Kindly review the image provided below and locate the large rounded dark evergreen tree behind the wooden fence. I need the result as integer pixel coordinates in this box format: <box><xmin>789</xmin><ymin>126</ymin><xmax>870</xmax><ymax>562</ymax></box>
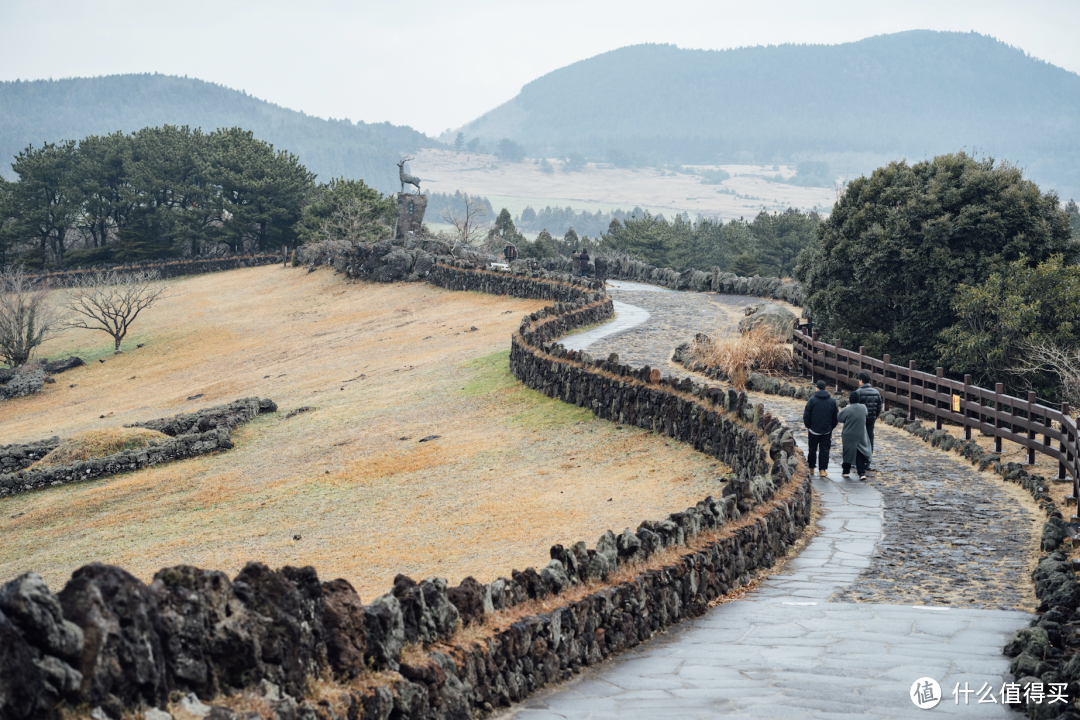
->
<box><xmin>795</xmin><ymin>152</ymin><xmax>1071</xmax><ymax>367</ymax></box>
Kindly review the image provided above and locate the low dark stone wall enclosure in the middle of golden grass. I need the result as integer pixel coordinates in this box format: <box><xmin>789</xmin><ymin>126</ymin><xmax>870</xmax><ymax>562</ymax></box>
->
<box><xmin>0</xmin><ymin>397</ymin><xmax>278</xmax><ymax>497</ymax></box>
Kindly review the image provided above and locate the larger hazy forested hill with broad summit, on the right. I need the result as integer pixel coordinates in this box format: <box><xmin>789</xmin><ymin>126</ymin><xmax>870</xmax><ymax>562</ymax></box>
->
<box><xmin>461</xmin><ymin>30</ymin><xmax>1080</xmax><ymax>196</ymax></box>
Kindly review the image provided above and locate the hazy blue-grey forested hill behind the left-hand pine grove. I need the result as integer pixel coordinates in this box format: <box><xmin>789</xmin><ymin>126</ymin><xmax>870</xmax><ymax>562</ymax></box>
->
<box><xmin>0</xmin><ymin>74</ymin><xmax>438</xmax><ymax>192</ymax></box>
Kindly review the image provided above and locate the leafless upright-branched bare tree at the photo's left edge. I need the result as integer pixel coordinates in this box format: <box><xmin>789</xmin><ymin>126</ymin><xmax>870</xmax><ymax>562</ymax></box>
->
<box><xmin>0</xmin><ymin>269</ymin><xmax>58</xmax><ymax>367</ymax></box>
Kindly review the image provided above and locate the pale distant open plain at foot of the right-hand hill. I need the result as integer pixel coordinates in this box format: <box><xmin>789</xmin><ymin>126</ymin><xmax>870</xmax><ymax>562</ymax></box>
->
<box><xmin>410</xmin><ymin>150</ymin><xmax>836</xmax><ymax>221</ymax></box>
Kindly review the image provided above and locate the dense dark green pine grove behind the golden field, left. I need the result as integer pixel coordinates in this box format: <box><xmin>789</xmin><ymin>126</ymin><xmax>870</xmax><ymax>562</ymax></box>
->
<box><xmin>0</xmin><ymin>125</ymin><xmax>403</xmax><ymax>270</ymax></box>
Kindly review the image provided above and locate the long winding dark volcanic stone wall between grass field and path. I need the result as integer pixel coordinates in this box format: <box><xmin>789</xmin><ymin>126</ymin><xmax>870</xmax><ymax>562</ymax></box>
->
<box><xmin>0</xmin><ymin>267</ymin><xmax>811</xmax><ymax>720</ymax></box>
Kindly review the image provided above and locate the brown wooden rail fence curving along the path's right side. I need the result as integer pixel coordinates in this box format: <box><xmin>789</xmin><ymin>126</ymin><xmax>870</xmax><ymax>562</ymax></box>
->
<box><xmin>792</xmin><ymin>324</ymin><xmax>1080</xmax><ymax>502</ymax></box>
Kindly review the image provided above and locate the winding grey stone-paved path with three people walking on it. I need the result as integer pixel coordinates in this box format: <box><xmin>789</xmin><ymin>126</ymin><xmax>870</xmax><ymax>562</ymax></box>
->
<box><xmin>500</xmin><ymin>287</ymin><xmax>1034</xmax><ymax>720</ymax></box>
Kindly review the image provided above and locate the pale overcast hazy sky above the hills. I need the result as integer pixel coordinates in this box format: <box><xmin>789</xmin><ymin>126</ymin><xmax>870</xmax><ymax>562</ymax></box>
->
<box><xmin>0</xmin><ymin>0</ymin><xmax>1080</xmax><ymax>135</ymax></box>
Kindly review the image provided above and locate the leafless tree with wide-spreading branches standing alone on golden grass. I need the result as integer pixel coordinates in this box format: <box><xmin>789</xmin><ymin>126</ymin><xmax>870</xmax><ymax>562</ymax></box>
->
<box><xmin>64</xmin><ymin>271</ymin><xmax>165</xmax><ymax>353</ymax></box>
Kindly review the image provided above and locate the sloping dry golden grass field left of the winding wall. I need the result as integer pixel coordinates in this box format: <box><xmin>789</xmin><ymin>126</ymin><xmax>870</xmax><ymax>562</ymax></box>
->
<box><xmin>0</xmin><ymin>267</ymin><xmax>723</xmax><ymax>600</ymax></box>
